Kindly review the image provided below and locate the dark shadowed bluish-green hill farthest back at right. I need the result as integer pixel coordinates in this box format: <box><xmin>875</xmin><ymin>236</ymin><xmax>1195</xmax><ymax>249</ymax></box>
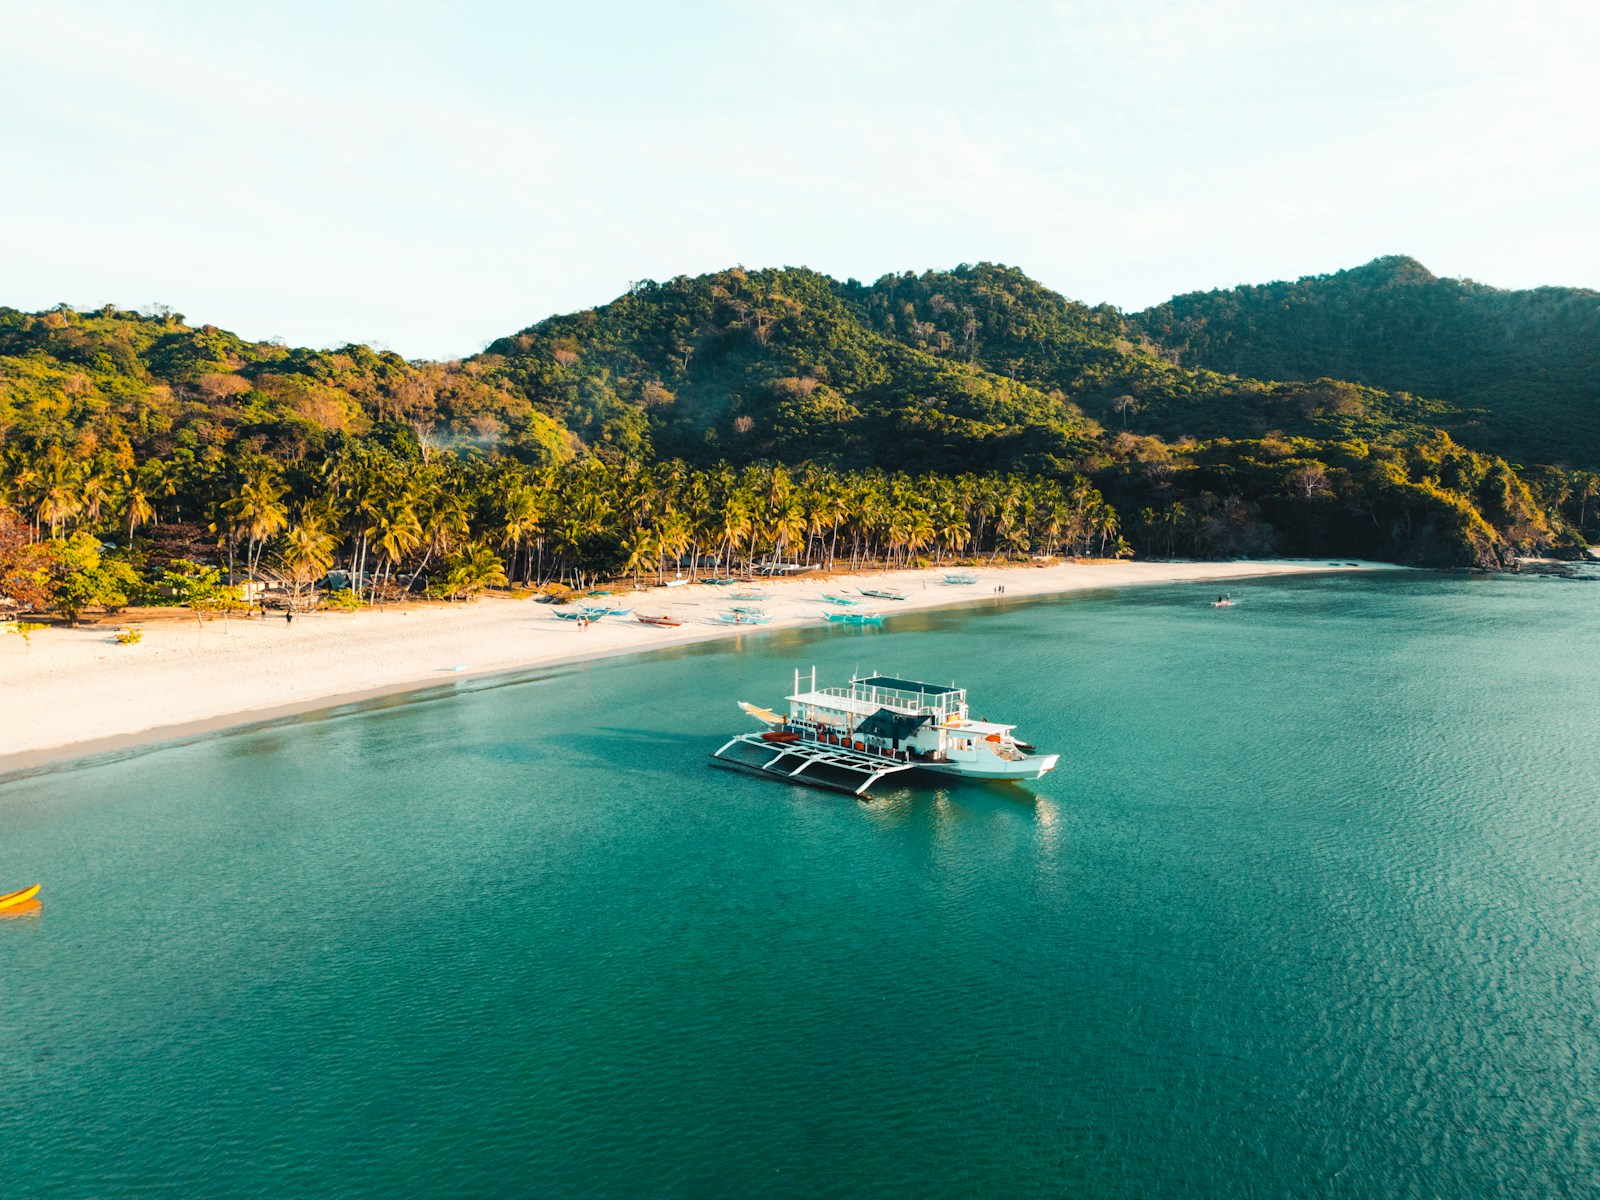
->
<box><xmin>1133</xmin><ymin>256</ymin><xmax>1600</xmax><ymax>469</ymax></box>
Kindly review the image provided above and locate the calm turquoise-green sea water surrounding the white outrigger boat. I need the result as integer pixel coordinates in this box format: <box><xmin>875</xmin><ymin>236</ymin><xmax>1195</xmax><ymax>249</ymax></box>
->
<box><xmin>0</xmin><ymin>576</ymin><xmax>1600</xmax><ymax>1200</ymax></box>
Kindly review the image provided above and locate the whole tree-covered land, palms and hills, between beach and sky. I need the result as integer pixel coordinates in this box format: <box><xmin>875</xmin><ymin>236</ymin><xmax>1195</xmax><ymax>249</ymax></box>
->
<box><xmin>0</xmin><ymin>258</ymin><xmax>1600</xmax><ymax>619</ymax></box>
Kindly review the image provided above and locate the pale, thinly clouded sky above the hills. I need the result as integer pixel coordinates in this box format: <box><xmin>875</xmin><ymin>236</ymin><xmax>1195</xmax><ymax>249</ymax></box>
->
<box><xmin>0</xmin><ymin>0</ymin><xmax>1600</xmax><ymax>358</ymax></box>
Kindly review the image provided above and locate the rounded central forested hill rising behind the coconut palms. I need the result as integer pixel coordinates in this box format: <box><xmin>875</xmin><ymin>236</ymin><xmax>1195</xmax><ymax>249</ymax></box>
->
<box><xmin>472</xmin><ymin>264</ymin><xmax>1465</xmax><ymax>469</ymax></box>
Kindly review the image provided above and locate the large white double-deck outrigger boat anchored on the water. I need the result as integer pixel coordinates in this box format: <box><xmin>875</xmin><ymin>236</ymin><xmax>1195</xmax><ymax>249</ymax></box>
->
<box><xmin>712</xmin><ymin>667</ymin><xmax>1061</xmax><ymax>797</ymax></box>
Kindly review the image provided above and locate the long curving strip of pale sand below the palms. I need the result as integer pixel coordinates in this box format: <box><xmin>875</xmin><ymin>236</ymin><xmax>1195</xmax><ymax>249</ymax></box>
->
<box><xmin>0</xmin><ymin>560</ymin><xmax>1398</xmax><ymax>773</ymax></box>
